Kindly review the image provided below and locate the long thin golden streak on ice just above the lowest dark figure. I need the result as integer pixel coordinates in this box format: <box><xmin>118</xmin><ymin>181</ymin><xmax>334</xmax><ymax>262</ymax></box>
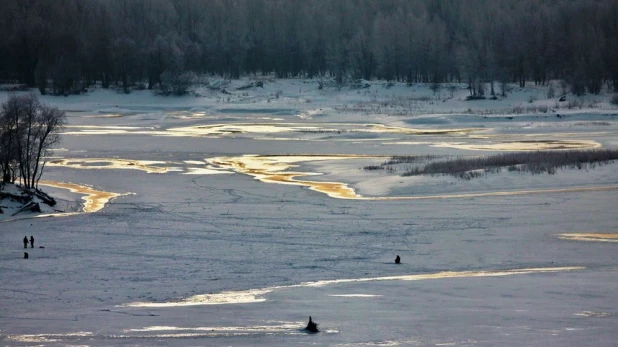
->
<box><xmin>123</xmin><ymin>266</ymin><xmax>585</xmax><ymax>307</ymax></box>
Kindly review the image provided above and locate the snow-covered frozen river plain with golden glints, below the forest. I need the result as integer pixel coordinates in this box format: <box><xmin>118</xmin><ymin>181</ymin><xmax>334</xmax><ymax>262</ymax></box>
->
<box><xmin>0</xmin><ymin>80</ymin><xmax>618</xmax><ymax>347</ymax></box>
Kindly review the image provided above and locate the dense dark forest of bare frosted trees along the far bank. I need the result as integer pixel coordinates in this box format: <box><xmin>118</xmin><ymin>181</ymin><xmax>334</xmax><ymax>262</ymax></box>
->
<box><xmin>0</xmin><ymin>0</ymin><xmax>618</xmax><ymax>94</ymax></box>
